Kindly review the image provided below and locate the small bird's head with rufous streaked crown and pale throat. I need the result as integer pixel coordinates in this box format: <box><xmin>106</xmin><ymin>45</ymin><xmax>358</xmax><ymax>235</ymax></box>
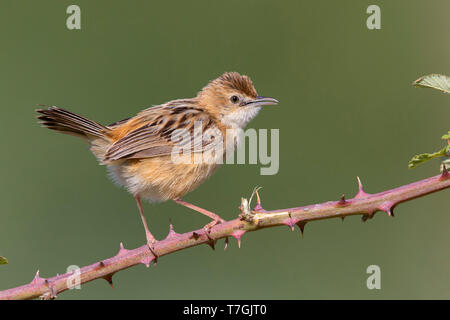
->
<box><xmin>197</xmin><ymin>72</ymin><xmax>278</xmax><ymax>128</ymax></box>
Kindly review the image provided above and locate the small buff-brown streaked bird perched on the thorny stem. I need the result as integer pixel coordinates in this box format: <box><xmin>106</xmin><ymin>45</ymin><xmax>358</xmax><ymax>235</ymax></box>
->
<box><xmin>36</xmin><ymin>72</ymin><xmax>278</xmax><ymax>252</ymax></box>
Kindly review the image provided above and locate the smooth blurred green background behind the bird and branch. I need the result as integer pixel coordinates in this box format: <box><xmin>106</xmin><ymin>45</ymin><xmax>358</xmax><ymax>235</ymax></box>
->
<box><xmin>0</xmin><ymin>0</ymin><xmax>450</xmax><ymax>299</ymax></box>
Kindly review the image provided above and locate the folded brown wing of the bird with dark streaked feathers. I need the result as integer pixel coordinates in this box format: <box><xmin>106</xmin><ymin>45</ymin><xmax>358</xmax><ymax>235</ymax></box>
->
<box><xmin>103</xmin><ymin>105</ymin><xmax>218</xmax><ymax>162</ymax></box>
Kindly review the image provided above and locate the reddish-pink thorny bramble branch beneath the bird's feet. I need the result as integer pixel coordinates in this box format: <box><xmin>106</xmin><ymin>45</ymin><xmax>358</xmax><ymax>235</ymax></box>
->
<box><xmin>0</xmin><ymin>166</ymin><xmax>450</xmax><ymax>299</ymax></box>
